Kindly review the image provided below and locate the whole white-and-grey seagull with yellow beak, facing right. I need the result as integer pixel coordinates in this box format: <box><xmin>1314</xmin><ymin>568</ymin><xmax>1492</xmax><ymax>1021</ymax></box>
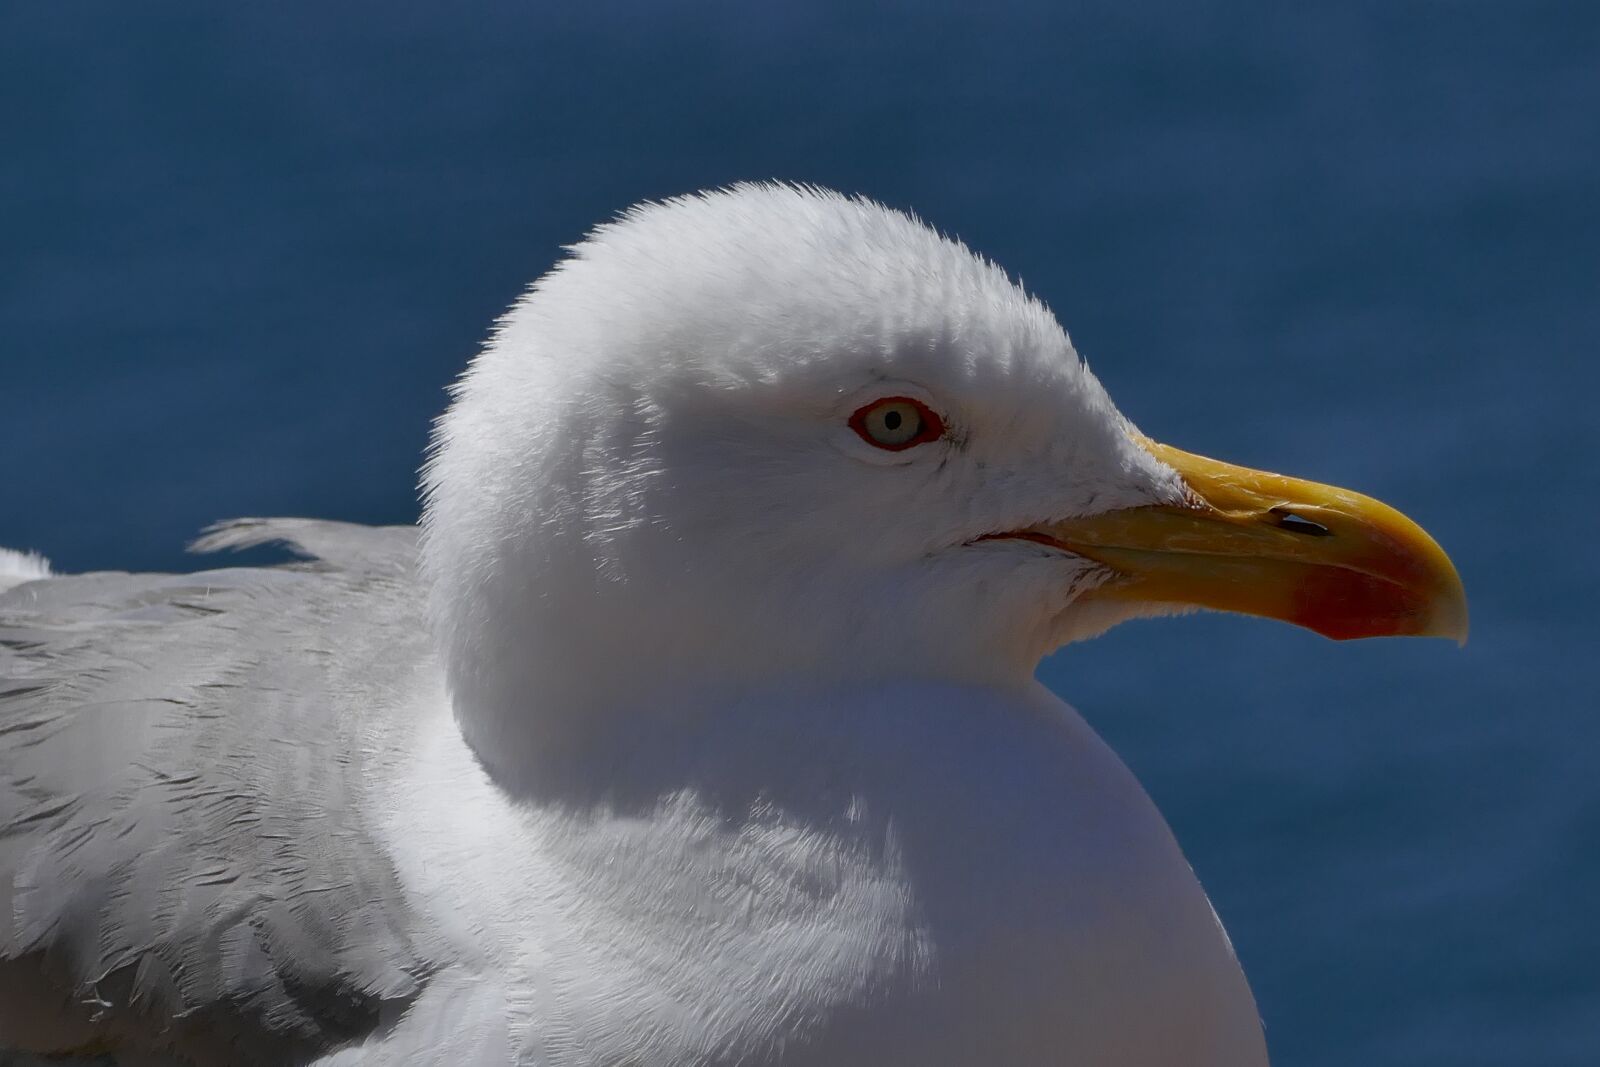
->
<box><xmin>0</xmin><ymin>184</ymin><xmax>1467</xmax><ymax>1067</ymax></box>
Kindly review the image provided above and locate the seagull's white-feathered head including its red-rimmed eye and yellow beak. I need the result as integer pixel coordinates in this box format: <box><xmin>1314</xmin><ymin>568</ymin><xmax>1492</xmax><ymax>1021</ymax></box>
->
<box><xmin>422</xmin><ymin>186</ymin><xmax>1466</xmax><ymax>777</ymax></box>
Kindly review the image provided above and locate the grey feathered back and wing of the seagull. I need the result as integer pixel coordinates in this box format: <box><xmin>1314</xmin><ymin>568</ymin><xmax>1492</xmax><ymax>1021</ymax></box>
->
<box><xmin>0</xmin><ymin>520</ymin><xmax>437</xmax><ymax>1062</ymax></box>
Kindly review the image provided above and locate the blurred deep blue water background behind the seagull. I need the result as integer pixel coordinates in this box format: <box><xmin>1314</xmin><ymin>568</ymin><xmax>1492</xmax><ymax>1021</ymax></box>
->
<box><xmin>0</xmin><ymin>0</ymin><xmax>1600</xmax><ymax>1065</ymax></box>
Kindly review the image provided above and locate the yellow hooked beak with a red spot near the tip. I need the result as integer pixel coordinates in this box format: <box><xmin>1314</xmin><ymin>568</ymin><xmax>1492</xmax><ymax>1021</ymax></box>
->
<box><xmin>1021</xmin><ymin>440</ymin><xmax>1467</xmax><ymax>643</ymax></box>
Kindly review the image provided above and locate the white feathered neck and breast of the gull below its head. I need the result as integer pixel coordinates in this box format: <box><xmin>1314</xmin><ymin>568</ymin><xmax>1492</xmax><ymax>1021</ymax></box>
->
<box><xmin>380</xmin><ymin>685</ymin><xmax>1266</xmax><ymax>1067</ymax></box>
